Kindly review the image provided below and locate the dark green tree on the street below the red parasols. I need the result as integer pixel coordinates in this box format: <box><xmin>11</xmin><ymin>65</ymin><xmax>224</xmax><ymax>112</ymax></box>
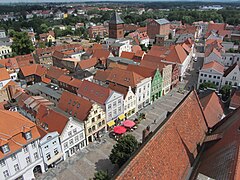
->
<box><xmin>109</xmin><ymin>134</ymin><xmax>138</xmax><ymax>167</ymax></box>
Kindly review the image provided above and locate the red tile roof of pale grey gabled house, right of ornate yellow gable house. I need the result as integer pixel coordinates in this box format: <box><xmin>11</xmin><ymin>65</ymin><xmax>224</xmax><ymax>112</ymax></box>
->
<box><xmin>77</xmin><ymin>80</ymin><xmax>112</xmax><ymax>105</ymax></box>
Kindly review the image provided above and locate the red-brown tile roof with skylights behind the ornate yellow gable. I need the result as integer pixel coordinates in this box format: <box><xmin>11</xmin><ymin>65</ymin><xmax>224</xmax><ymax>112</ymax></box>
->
<box><xmin>58</xmin><ymin>91</ymin><xmax>92</xmax><ymax>121</ymax></box>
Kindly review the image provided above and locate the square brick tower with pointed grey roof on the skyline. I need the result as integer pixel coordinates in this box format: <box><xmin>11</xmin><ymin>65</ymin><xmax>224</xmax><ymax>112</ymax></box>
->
<box><xmin>109</xmin><ymin>12</ymin><xmax>124</xmax><ymax>39</ymax></box>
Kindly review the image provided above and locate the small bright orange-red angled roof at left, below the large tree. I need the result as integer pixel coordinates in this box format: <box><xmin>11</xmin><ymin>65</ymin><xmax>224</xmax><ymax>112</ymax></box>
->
<box><xmin>20</xmin><ymin>64</ymin><xmax>47</xmax><ymax>77</ymax></box>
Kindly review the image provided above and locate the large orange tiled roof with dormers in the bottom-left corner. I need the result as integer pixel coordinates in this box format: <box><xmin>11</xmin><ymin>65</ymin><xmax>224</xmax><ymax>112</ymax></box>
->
<box><xmin>0</xmin><ymin>110</ymin><xmax>40</xmax><ymax>159</ymax></box>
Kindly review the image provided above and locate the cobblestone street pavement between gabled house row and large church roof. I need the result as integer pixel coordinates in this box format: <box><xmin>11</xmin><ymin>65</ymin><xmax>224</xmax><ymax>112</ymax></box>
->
<box><xmin>37</xmin><ymin>58</ymin><xmax>202</xmax><ymax>180</ymax></box>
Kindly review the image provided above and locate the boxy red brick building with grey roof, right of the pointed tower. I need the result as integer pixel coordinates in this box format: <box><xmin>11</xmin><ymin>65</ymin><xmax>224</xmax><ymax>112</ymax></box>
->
<box><xmin>147</xmin><ymin>19</ymin><xmax>170</xmax><ymax>39</ymax></box>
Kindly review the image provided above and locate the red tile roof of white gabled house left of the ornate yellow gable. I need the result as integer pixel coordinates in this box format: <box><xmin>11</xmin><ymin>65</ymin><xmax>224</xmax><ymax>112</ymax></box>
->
<box><xmin>36</xmin><ymin>105</ymin><xmax>69</xmax><ymax>134</ymax></box>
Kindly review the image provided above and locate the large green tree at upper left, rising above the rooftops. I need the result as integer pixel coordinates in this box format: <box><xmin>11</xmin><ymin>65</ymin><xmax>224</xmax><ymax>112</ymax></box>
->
<box><xmin>12</xmin><ymin>32</ymin><xmax>34</xmax><ymax>55</ymax></box>
